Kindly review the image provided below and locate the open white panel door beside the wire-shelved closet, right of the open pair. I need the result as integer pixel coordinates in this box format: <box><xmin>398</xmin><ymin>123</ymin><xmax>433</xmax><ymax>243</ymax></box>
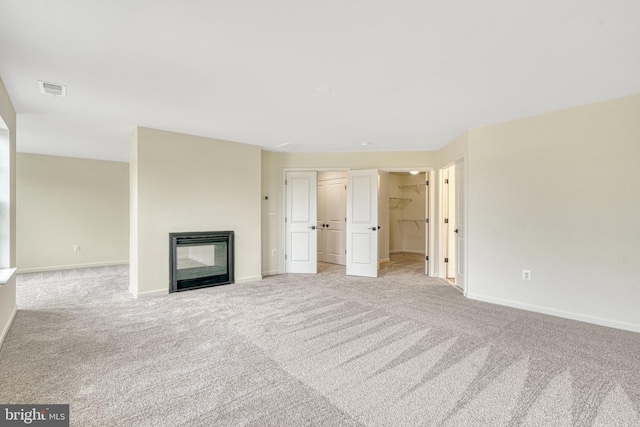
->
<box><xmin>347</xmin><ymin>169</ymin><xmax>378</xmax><ymax>277</ymax></box>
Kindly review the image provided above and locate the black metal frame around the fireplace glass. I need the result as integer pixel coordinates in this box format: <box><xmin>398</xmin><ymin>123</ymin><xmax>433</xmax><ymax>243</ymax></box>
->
<box><xmin>169</xmin><ymin>231</ymin><xmax>235</xmax><ymax>293</ymax></box>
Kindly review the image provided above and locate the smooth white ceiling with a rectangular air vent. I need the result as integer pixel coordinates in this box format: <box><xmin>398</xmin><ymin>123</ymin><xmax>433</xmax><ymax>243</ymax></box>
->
<box><xmin>0</xmin><ymin>0</ymin><xmax>640</xmax><ymax>161</ymax></box>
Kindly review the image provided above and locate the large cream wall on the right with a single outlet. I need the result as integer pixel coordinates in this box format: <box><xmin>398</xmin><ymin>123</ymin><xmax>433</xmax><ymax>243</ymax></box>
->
<box><xmin>467</xmin><ymin>95</ymin><xmax>640</xmax><ymax>332</ymax></box>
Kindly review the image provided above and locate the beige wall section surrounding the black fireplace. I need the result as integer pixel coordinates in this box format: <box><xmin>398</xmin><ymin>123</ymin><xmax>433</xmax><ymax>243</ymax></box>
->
<box><xmin>130</xmin><ymin>127</ymin><xmax>261</xmax><ymax>296</ymax></box>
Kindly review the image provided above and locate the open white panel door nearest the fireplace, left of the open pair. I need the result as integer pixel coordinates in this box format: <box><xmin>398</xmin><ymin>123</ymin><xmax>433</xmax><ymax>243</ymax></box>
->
<box><xmin>285</xmin><ymin>171</ymin><xmax>318</xmax><ymax>274</ymax></box>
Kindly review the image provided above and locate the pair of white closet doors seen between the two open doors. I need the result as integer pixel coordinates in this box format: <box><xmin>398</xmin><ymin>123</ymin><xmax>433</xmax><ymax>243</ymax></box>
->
<box><xmin>317</xmin><ymin>173</ymin><xmax>347</xmax><ymax>265</ymax></box>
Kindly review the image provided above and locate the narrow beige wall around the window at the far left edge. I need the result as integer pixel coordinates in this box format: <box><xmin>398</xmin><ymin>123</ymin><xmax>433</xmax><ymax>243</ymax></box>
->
<box><xmin>0</xmin><ymin>78</ymin><xmax>17</xmax><ymax>346</ymax></box>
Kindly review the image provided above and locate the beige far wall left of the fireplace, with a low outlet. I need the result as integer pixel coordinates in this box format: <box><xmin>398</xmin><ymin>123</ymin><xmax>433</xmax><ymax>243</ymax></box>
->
<box><xmin>17</xmin><ymin>153</ymin><xmax>129</xmax><ymax>273</ymax></box>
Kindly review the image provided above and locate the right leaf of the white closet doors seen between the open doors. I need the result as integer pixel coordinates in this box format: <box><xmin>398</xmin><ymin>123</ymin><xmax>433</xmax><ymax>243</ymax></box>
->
<box><xmin>324</xmin><ymin>178</ymin><xmax>347</xmax><ymax>265</ymax></box>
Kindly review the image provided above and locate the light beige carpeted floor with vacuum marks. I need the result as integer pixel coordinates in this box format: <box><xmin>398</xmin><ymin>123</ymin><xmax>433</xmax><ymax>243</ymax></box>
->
<box><xmin>0</xmin><ymin>255</ymin><xmax>640</xmax><ymax>426</ymax></box>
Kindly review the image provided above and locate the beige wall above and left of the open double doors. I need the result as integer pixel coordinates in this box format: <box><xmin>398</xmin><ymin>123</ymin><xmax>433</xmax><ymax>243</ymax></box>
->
<box><xmin>262</xmin><ymin>151</ymin><xmax>436</xmax><ymax>275</ymax></box>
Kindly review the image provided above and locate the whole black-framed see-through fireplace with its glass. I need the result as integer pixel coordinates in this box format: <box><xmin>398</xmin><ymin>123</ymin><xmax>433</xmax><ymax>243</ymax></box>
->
<box><xmin>169</xmin><ymin>231</ymin><xmax>234</xmax><ymax>292</ymax></box>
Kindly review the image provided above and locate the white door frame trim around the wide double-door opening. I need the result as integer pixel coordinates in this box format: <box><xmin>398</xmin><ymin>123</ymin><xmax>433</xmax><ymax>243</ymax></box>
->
<box><xmin>280</xmin><ymin>166</ymin><xmax>438</xmax><ymax>277</ymax></box>
